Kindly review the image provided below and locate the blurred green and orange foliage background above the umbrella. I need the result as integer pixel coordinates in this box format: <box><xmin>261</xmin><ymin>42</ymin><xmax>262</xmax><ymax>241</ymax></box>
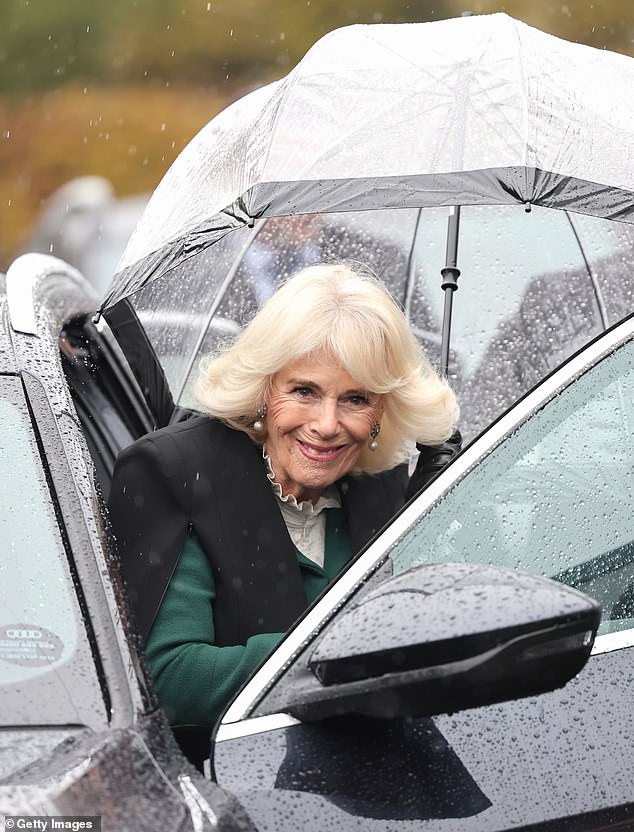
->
<box><xmin>0</xmin><ymin>0</ymin><xmax>634</xmax><ymax>270</ymax></box>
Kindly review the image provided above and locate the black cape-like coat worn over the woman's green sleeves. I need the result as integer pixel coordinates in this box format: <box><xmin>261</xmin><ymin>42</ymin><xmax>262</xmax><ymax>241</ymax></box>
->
<box><xmin>110</xmin><ymin>416</ymin><xmax>414</xmax><ymax>646</ymax></box>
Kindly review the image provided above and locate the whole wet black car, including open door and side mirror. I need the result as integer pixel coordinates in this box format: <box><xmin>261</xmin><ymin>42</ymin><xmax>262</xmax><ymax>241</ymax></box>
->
<box><xmin>0</xmin><ymin>255</ymin><xmax>634</xmax><ymax>830</ymax></box>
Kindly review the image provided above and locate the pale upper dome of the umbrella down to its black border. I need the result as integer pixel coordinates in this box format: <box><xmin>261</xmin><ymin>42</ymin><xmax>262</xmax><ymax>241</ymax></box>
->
<box><xmin>103</xmin><ymin>14</ymin><xmax>634</xmax><ymax>307</ymax></box>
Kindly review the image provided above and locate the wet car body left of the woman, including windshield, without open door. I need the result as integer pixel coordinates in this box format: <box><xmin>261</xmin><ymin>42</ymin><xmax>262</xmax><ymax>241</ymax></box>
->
<box><xmin>0</xmin><ymin>255</ymin><xmax>252</xmax><ymax>832</ymax></box>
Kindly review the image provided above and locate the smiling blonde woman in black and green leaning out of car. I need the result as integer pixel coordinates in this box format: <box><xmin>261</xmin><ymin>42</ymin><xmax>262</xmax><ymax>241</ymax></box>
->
<box><xmin>106</xmin><ymin>265</ymin><xmax>457</xmax><ymax>752</ymax></box>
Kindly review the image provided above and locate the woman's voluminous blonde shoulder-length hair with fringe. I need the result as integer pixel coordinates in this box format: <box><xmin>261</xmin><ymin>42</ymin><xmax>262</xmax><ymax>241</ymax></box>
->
<box><xmin>196</xmin><ymin>263</ymin><xmax>458</xmax><ymax>473</ymax></box>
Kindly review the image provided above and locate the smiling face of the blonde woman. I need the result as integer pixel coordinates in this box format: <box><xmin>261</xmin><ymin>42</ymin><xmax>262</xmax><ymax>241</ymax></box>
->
<box><xmin>265</xmin><ymin>354</ymin><xmax>382</xmax><ymax>502</ymax></box>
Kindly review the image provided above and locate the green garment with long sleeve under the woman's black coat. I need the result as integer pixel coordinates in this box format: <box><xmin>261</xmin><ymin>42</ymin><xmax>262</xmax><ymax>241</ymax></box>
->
<box><xmin>145</xmin><ymin>509</ymin><xmax>352</xmax><ymax>726</ymax></box>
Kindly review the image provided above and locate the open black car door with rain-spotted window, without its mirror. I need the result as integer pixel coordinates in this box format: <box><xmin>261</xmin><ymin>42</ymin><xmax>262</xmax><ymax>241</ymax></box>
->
<box><xmin>213</xmin><ymin>319</ymin><xmax>634</xmax><ymax>832</ymax></box>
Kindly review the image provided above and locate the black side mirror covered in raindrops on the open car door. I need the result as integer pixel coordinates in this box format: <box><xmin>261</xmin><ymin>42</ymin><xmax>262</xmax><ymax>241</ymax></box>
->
<box><xmin>284</xmin><ymin>564</ymin><xmax>601</xmax><ymax>721</ymax></box>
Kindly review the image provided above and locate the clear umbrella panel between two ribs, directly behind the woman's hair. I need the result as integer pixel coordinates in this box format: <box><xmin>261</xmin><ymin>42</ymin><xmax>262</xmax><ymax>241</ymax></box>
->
<box><xmin>179</xmin><ymin>210</ymin><xmax>418</xmax><ymax>407</ymax></box>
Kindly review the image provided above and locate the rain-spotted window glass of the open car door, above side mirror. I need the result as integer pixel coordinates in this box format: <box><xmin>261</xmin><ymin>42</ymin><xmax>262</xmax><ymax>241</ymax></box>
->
<box><xmin>390</xmin><ymin>332</ymin><xmax>634</xmax><ymax>634</ymax></box>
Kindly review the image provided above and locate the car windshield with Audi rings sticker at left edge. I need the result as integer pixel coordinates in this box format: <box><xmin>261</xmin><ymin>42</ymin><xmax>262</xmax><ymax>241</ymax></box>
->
<box><xmin>0</xmin><ymin>376</ymin><xmax>106</xmax><ymax>725</ymax></box>
